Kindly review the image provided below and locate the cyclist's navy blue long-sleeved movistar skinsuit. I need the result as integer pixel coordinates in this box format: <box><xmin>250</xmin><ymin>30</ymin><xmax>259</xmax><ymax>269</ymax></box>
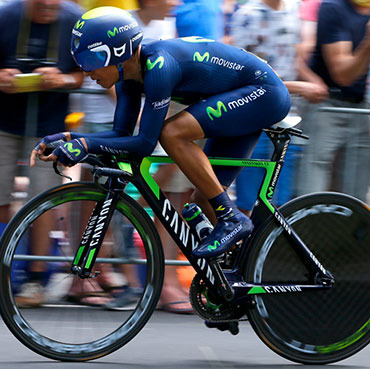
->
<box><xmin>72</xmin><ymin>37</ymin><xmax>290</xmax><ymax>185</ymax></box>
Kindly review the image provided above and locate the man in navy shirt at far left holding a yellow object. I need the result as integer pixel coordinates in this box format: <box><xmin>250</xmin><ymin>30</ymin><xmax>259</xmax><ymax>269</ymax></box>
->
<box><xmin>0</xmin><ymin>0</ymin><xmax>83</xmax><ymax>306</ymax></box>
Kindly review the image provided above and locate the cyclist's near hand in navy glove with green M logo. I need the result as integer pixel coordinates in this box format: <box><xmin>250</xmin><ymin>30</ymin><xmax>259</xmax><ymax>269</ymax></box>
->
<box><xmin>50</xmin><ymin>138</ymin><xmax>88</xmax><ymax>167</ymax></box>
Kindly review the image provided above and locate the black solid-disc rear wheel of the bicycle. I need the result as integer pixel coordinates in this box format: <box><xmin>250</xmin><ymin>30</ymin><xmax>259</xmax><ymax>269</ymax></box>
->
<box><xmin>244</xmin><ymin>193</ymin><xmax>370</xmax><ymax>364</ymax></box>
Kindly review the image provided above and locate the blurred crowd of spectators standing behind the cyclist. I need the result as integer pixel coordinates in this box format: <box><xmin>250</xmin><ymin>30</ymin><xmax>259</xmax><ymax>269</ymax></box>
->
<box><xmin>0</xmin><ymin>0</ymin><xmax>370</xmax><ymax>313</ymax></box>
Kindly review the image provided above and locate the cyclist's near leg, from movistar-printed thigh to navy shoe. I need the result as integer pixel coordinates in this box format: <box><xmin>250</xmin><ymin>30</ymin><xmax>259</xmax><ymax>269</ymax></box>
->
<box><xmin>160</xmin><ymin>82</ymin><xmax>290</xmax><ymax>257</ymax></box>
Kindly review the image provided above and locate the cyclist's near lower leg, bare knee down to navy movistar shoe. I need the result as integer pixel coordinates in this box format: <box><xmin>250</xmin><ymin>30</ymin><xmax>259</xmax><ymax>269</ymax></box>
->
<box><xmin>160</xmin><ymin>111</ymin><xmax>252</xmax><ymax>257</ymax></box>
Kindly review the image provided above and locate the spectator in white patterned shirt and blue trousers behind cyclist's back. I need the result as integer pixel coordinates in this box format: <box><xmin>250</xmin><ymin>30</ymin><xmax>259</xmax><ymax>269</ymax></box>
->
<box><xmin>231</xmin><ymin>0</ymin><xmax>325</xmax><ymax>214</ymax></box>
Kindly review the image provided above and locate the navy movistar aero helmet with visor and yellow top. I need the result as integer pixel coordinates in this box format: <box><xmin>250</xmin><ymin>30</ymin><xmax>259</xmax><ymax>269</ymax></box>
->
<box><xmin>71</xmin><ymin>6</ymin><xmax>143</xmax><ymax>72</ymax></box>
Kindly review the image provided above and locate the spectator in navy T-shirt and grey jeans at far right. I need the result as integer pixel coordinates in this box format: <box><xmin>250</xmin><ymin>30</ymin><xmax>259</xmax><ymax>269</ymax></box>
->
<box><xmin>298</xmin><ymin>0</ymin><xmax>370</xmax><ymax>201</ymax></box>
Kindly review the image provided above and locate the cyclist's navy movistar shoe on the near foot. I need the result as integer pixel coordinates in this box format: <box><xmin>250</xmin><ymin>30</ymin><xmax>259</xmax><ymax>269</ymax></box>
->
<box><xmin>193</xmin><ymin>213</ymin><xmax>253</xmax><ymax>258</ymax></box>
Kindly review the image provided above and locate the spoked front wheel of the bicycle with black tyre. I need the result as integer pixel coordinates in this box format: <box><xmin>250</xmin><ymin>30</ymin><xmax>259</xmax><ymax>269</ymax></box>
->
<box><xmin>0</xmin><ymin>182</ymin><xmax>164</xmax><ymax>361</ymax></box>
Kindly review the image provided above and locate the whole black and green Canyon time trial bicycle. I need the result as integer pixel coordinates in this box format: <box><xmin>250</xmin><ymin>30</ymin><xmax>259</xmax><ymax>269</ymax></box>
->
<box><xmin>0</xmin><ymin>118</ymin><xmax>370</xmax><ymax>364</ymax></box>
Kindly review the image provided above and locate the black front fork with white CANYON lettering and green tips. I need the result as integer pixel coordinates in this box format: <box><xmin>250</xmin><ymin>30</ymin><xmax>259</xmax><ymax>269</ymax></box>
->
<box><xmin>71</xmin><ymin>180</ymin><xmax>121</xmax><ymax>278</ymax></box>
